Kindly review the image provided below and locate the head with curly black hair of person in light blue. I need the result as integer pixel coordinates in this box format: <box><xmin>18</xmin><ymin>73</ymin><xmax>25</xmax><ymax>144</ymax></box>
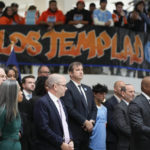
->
<box><xmin>92</xmin><ymin>83</ymin><xmax>108</xmax><ymax>103</ymax></box>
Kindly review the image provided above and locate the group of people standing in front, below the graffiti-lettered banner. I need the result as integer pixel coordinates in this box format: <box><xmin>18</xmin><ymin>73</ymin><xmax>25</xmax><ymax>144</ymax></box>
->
<box><xmin>0</xmin><ymin>62</ymin><xmax>150</xmax><ymax>150</ymax></box>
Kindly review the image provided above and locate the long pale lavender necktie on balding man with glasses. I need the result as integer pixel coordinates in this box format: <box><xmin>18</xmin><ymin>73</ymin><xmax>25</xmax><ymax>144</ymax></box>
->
<box><xmin>57</xmin><ymin>100</ymin><xmax>70</xmax><ymax>143</ymax></box>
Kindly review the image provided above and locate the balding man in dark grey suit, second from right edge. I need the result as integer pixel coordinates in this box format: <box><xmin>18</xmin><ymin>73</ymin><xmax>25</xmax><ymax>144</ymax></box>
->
<box><xmin>114</xmin><ymin>84</ymin><xmax>135</xmax><ymax>150</ymax></box>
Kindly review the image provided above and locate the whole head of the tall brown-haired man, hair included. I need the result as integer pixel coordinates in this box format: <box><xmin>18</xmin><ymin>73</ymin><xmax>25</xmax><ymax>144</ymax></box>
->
<box><xmin>68</xmin><ymin>62</ymin><xmax>84</xmax><ymax>83</ymax></box>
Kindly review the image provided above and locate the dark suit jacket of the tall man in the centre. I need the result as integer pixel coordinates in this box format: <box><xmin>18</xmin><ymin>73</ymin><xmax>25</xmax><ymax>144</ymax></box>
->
<box><xmin>63</xmin><ymin>81</ymin><xmax>97</xmax><ymax>140</ymax></box>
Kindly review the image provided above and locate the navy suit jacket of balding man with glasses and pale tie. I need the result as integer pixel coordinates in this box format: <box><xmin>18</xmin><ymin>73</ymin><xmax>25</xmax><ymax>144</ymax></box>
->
<box><xmin>34</xmin><ymin>94</ymin><xmax>72</xmax><ymax>150</ymax></box>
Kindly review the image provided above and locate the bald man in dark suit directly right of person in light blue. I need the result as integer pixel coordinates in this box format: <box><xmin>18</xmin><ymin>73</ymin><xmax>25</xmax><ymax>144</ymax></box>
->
<box><xmin>104</xmin><ymin>81</ymin><xmax>125</xmax><ymax>150</ymax></box>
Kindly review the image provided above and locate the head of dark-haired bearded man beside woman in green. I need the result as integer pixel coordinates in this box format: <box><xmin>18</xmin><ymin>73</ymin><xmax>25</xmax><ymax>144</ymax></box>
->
<box><xmin>22</xmin><ymin>75</ymin><xmax>35</xmax><ymax>93</ymax></box>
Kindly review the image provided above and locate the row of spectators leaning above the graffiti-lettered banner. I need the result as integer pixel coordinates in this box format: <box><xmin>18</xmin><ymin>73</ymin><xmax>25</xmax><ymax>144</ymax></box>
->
<box><xmin>0</xmin><ymin>0</ymin><xmax>150</xmax><ymax>32</ymax></box>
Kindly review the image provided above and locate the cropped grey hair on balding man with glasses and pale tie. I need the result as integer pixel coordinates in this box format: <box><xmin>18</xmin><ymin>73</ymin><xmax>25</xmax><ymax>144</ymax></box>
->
<box><xmin>46</xmin><ymin>74</ymin><xmax>63</xmax><ymax>89</ymax></box>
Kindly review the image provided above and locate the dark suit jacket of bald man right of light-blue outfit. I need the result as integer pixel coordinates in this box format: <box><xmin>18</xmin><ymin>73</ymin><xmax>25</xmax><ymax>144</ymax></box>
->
<box><xmin>104</xmin><ymin>96</ymin><xmax>118</xmax><ymax>144</ymax></box>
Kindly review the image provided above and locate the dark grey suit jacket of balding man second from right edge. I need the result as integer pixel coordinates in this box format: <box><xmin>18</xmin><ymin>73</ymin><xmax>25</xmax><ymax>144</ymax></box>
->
<box><xmin>114</xmin><ymin>100</ymin><xmax>131</xmax><ymax>150</ymax></box>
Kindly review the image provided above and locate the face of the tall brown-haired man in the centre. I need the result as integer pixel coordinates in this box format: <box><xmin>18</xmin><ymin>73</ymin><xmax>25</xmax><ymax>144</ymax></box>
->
<box><xmin>70</xmin><ymin>65</ymin><xmax>84</xmax><ymax>81</ymax></box>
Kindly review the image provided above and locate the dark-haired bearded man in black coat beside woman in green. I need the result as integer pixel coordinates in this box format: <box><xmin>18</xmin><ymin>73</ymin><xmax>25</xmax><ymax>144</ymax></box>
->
<box><xmin>18</xmin><ymin>75</ymin><xmax>35</xmax><ymax>150</ymax></box>
